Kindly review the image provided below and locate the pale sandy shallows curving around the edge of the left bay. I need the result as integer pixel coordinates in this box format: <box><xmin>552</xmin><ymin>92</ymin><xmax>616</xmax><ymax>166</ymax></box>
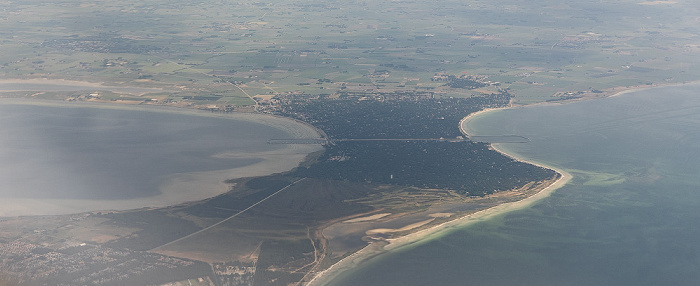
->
<box><xmin>0</xmin><ymin>98</ymin><xmax>321</xmax><ymax>217</ymax></box>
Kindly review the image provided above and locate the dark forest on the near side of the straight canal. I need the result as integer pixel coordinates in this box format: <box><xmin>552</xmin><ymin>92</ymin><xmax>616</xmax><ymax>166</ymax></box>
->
<box><xmin>295</xmin><ymin>141</ymin><xmax>556</xmax><ymax>196</ymax></box>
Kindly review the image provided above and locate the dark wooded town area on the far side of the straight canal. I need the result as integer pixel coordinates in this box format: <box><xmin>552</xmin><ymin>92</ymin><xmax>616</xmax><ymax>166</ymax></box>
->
<box><xmin>281</xmin><ymin>93</ymin><xmax>510</xmax><ymax>139</ymax></box>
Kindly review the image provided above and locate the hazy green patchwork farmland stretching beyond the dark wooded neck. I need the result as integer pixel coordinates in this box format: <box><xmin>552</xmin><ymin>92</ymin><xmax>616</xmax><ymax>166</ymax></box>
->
<box><xmin>0</xmin><ymin>0</ymin><xmax>700</xmax><ymax>105</ymax></box>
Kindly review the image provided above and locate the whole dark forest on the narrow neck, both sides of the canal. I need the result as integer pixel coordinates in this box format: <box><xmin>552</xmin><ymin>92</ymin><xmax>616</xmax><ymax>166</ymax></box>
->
<box><xmin>286</xmin><ymin>94</ymin><xmax>556</xmax><ymax>196</ymax></box>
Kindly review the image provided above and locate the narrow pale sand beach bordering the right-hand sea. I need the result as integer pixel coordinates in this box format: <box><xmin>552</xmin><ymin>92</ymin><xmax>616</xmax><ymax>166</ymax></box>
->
<box><xmin>306</xmin><ymin>105</ymin><xmax>572</xmax><ymax>285</ymax></box>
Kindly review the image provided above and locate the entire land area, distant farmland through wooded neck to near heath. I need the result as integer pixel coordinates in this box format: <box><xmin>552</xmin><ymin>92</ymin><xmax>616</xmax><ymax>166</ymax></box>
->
<box><xmin>0</xmin><ymin>0</ymin><xmax>700</xmax><ymax>285</ymax></box>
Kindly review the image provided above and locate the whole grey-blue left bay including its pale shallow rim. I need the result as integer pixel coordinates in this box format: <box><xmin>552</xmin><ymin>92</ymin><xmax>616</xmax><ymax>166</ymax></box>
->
<box><xmin>0</xmin><ymin>100</ymin><xmax>320</xmax><ymax>216</ymax></box>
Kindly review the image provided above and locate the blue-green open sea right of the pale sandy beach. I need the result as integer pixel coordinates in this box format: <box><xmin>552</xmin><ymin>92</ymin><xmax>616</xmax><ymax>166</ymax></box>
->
<box><xmin>331</xmin><ymin>85</ymin><xmax>700</xmax><ymax>285</ymax></box>
